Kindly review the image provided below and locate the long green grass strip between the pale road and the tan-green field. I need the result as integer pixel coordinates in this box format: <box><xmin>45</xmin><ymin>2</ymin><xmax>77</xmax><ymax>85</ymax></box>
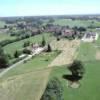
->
<box><xmin>2</xmin><ymin>51</ymin><xmax>59</xmax><ymax>79</ymax></box>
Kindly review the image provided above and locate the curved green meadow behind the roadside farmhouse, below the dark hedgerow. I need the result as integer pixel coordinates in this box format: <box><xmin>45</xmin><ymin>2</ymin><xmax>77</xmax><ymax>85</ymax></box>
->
<box><xmin>4</xmin><ymin>33</ymin><xmax>54</xmax><ymax>56</ymax></box>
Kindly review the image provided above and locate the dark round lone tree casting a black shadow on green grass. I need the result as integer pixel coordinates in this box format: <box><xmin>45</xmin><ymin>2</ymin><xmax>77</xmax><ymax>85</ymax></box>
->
<box><xmin>68</xmin><ymin>60</ymin><xmax>85</xmax><ymax>76</ymax></box>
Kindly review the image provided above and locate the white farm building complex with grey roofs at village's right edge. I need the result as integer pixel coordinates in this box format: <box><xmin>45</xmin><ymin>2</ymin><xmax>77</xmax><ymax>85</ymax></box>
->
<box><xmin>82</xmin><ymin>32</ymin><xmax>98</xmax><ymax>42</ymax></box>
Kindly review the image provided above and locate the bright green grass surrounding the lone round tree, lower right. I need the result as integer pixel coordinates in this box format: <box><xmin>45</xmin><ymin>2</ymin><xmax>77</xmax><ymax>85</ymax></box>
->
<box><xmin>50</xmin><ymin>61</ymin><xmax>100</xmax><ymax>100</ymax></box>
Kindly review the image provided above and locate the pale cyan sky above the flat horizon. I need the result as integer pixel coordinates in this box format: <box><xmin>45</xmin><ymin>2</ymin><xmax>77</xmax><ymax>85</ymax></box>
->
<box><xmin>0</xmin><ymin>0</ymin><xmax>100</xmax><ymax>17</ymax></box>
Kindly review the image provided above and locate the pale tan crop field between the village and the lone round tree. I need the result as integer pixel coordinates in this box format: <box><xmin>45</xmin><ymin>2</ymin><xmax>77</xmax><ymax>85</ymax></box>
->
<box><xmin>51</xmin><ymin>39</ymin><xmax>80</xmax><ymax>66</ymax></box>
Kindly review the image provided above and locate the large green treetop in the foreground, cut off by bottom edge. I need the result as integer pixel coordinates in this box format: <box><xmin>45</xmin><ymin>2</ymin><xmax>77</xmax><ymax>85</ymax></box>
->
<box><xmin>41</xmin><ymin>78</ymin><xmax>63</xmax><ymax>100</ymax></box>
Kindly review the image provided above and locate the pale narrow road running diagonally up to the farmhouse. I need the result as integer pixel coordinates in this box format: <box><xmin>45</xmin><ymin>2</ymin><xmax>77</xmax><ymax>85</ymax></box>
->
<box><xmin>0</xmin><ymin>48</ymin><xmax>44</xmax><ymax>78</ymax></box>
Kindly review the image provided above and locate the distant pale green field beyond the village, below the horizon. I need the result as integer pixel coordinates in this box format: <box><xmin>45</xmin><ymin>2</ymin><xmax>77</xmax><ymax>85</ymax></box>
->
<box><xmin>54</xmin><ymin>19</ymin><xmax>100</xmax><ymax>27</ymax></box>
